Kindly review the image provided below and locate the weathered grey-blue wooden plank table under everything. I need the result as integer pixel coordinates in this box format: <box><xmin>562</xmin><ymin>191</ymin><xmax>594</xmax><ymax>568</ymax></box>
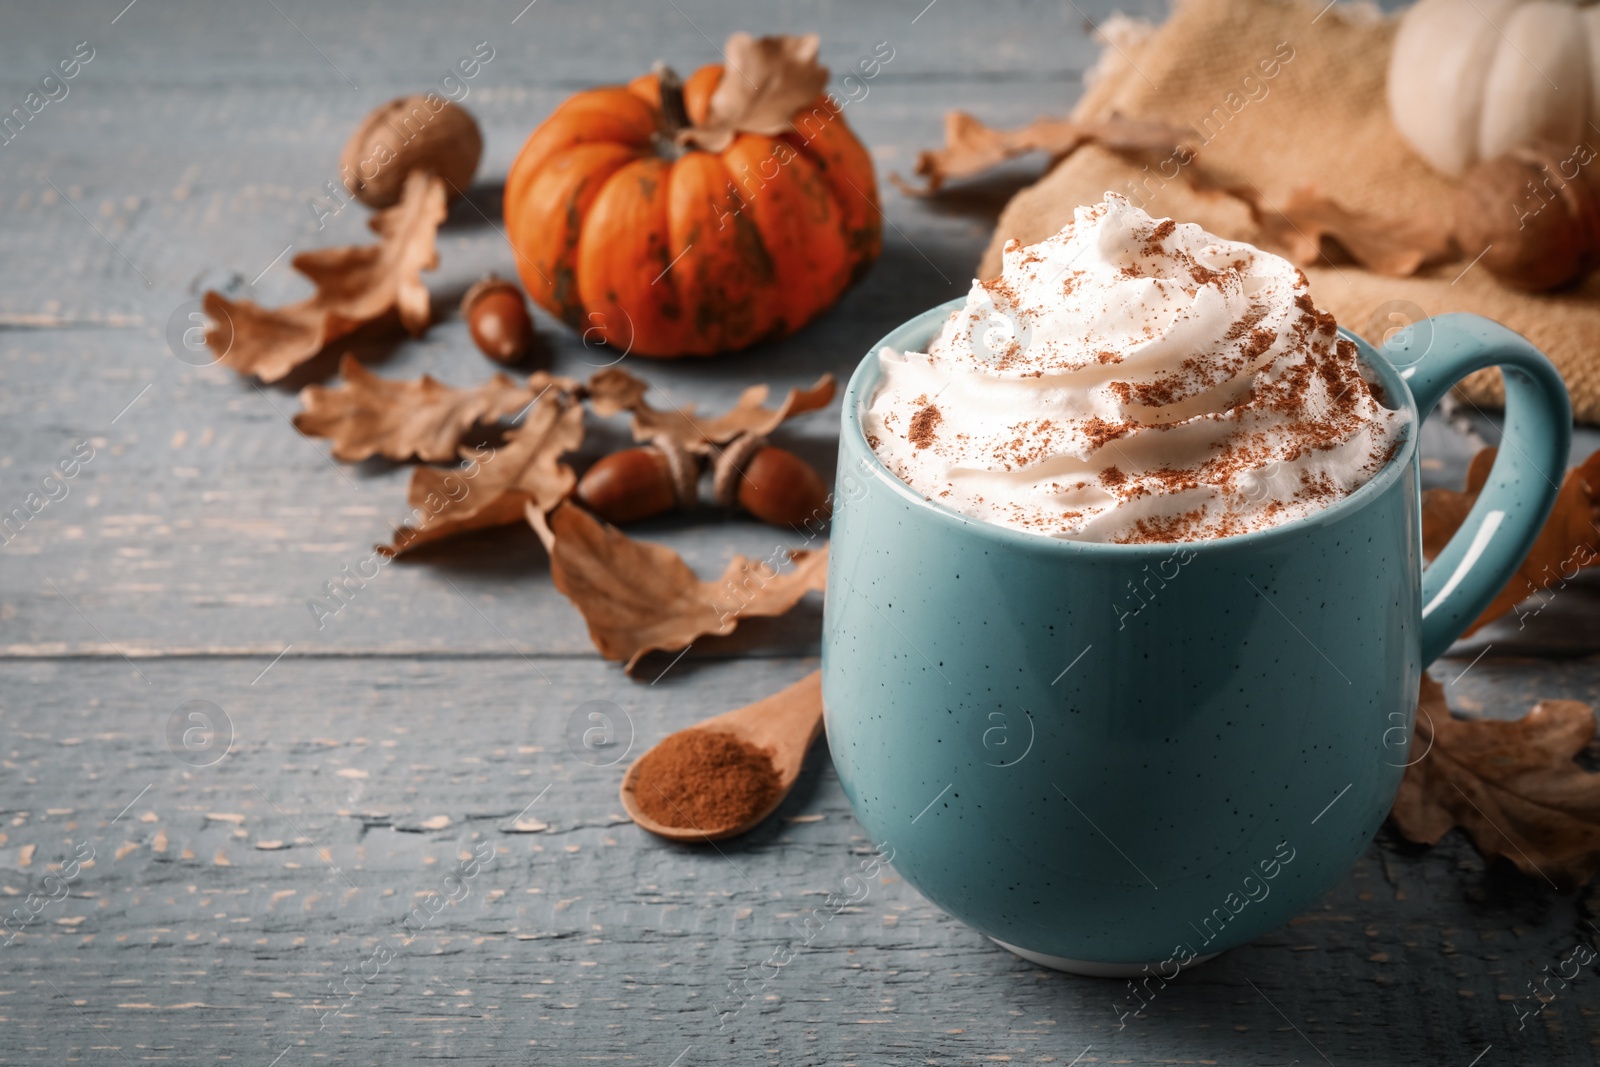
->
<box><xmin>0</xmin><ymin>0</ymin><xmax>1600</xmax><ymax>1067</ymax></box>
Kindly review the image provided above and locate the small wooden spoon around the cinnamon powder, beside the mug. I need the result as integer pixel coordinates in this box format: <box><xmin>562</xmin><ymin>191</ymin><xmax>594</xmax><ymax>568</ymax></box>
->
<box><xmin>622</xmin><ymin>670</ymin><xmax>822</xmax><ymax>841</ymax></box>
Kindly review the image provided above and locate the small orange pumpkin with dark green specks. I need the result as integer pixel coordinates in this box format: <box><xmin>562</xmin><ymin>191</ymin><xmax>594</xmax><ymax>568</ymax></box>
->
<box><xmin>506</xmin><ymin>66</ymin><xmax>882</xmax><ymax>357</ymax></box>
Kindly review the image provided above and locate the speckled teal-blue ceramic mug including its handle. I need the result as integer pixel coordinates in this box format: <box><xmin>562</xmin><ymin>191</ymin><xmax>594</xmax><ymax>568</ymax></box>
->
<box><xmin>822</xmin><ymin>301</ymin><xmax>1571</xmax><ymax>976</ymax></box>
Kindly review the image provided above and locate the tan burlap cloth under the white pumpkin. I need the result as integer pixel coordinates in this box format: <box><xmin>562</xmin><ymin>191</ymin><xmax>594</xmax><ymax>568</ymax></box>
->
<box><xmin>979</xmin><ymin>0</ymin><xmax>1600</xmax><ymax>422</ymax></box>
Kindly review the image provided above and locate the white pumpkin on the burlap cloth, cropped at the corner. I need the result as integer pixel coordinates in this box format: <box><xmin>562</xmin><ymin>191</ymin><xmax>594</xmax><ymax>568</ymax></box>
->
<box><xmin>1389</xmin><ymin>0</ymin><xmax>1600</xmax><ymax>176</ymax></box>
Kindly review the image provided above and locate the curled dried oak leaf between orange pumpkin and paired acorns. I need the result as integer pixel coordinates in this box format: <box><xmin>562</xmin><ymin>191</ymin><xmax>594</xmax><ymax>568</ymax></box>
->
<box><xmin>586</xmin><ymin>366</ymin><xmax>835</xmax><ymax>454</ymax></box>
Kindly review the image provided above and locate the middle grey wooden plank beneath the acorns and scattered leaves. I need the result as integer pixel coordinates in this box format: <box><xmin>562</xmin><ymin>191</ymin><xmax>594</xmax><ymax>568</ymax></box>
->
<box><xmin>0</xmin><ymin>355</ymin><xmax>1600</xmax><ymax>656</ymax></box>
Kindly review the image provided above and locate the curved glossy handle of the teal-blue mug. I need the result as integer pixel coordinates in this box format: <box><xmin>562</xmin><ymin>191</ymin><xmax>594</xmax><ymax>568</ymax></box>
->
<box><xmin>1379</xmin><ymin>314</ymin><xmax>1573</xmax><ymax>667</ymax></box>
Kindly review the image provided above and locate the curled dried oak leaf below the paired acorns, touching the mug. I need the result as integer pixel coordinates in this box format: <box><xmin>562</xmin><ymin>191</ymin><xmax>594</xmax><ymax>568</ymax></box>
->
<box><xmin>540</xmin><ymin>502</ymin><xmax>827</xmax><ymax>672</ymax></box>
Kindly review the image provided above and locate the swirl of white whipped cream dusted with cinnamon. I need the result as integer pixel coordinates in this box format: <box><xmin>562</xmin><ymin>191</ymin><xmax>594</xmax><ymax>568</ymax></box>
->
<box><xmin>862</xmin><ymin>194</ymin><xmax>1408</xmax><ymax>542</ymax></box>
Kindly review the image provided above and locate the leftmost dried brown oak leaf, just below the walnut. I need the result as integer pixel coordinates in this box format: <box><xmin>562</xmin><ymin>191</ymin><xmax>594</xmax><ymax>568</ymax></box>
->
<box><xmin>205</xmin><ymin>171</ymin><xmax>446</xmax><ymax>382</ymax></box>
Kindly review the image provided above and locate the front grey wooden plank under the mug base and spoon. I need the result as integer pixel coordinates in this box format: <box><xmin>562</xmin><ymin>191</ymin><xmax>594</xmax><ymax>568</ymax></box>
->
<box><xmin>0</xmin><ymin>656</ymin><xmax>1600</xmax><ymax>1064</ymax></box>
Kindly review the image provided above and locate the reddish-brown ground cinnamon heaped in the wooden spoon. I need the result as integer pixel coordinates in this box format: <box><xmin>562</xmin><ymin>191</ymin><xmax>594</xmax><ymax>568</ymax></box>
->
<box><xmin>634</xmin><ymin>729</ymin><xmax>779</xmax><ymax>830</ymax></box>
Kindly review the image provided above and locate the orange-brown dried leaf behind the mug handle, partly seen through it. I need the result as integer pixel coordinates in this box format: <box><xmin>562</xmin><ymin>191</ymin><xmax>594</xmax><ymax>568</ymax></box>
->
<box><xmin>1422</xmin><ymin>448</ymin><xmax>1600</xmax><ymax>633</ymax></box>
